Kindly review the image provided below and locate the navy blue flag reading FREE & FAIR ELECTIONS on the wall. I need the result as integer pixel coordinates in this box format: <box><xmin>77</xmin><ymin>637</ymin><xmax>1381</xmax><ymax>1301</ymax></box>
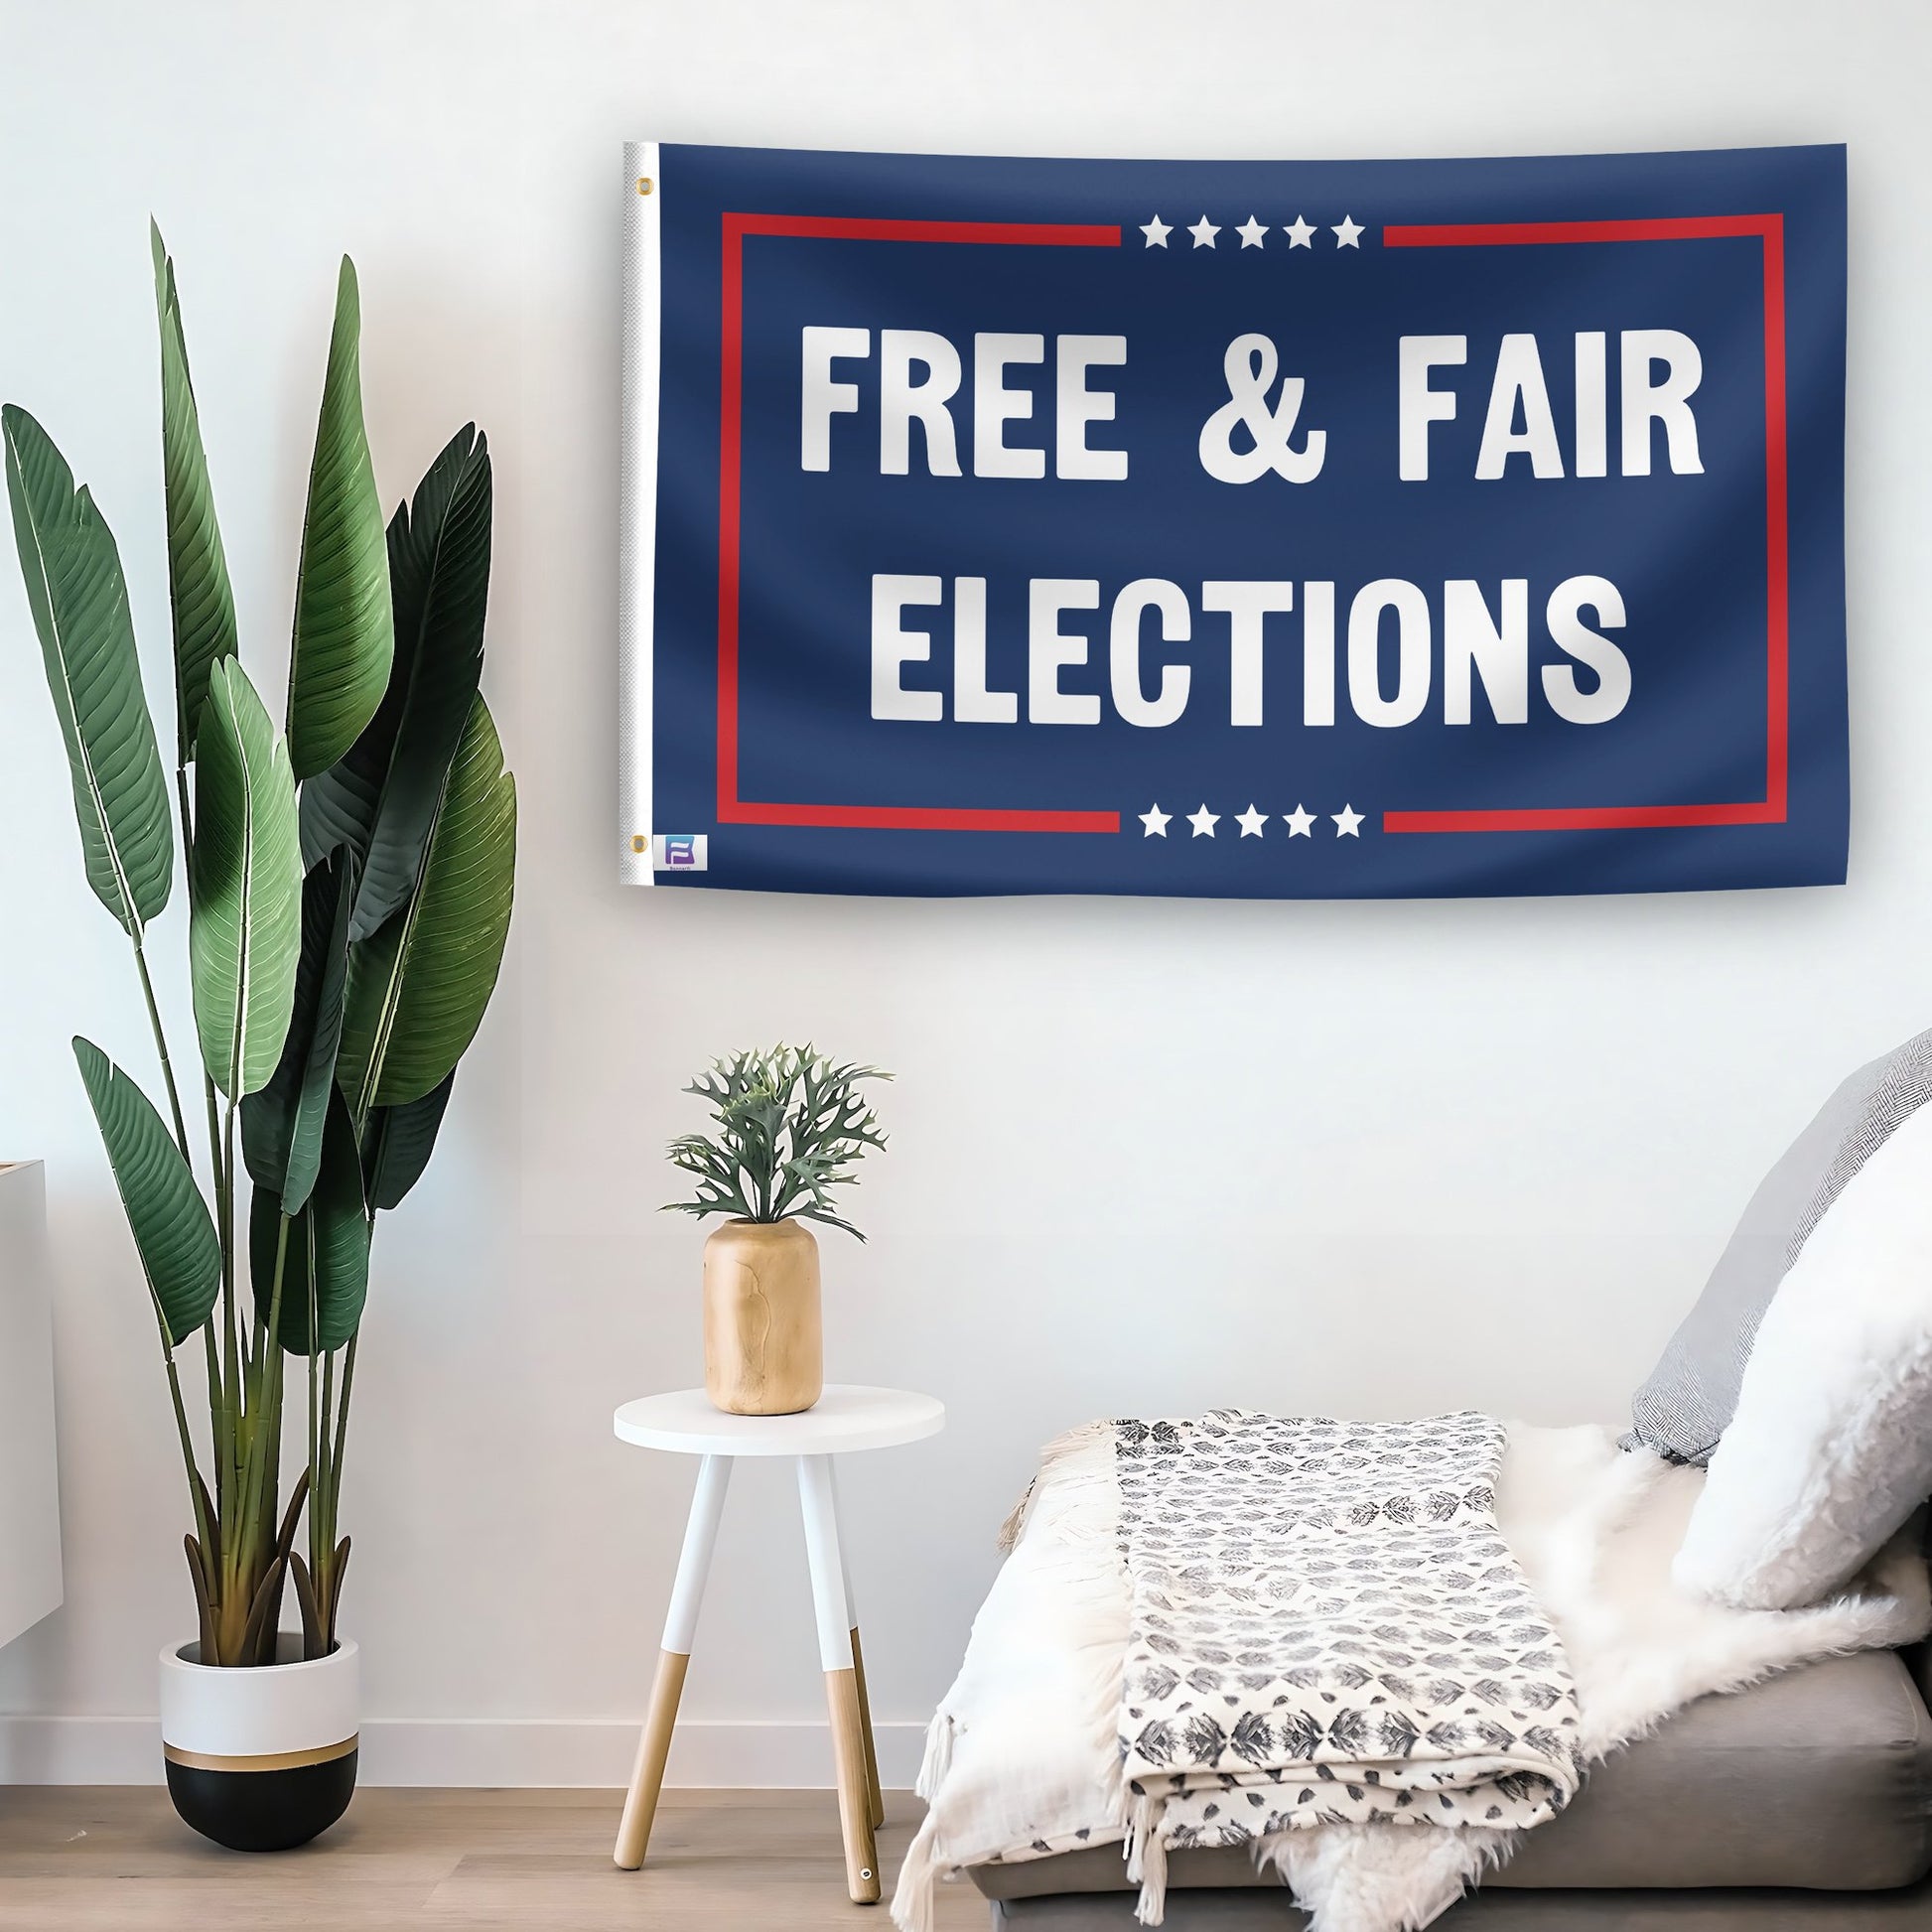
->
<box><xmin>621</xmin><ymin>145</ymin><xmax>1847</xmax><ymax>898</ymax></box>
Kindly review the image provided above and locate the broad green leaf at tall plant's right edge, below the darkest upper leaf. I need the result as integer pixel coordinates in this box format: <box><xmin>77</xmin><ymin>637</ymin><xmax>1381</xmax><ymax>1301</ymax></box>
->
<box><xmin>337</xmin><ymin>698</ymin><xmax>516</xmax><ymax>1121</ymax></box>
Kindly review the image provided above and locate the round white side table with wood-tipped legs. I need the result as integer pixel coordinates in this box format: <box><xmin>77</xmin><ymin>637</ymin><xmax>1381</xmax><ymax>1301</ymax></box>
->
<box><xmin>613</xmin><ymin>1383</ymin><xmax>947</xmax><ymax>1905</ymax></box>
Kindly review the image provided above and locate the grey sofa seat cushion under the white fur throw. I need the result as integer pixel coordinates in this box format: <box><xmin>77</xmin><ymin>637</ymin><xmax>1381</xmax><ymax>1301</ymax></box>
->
<box><xmin>972</xmin><ymin>1650</ymin><xmax>1932</xmax><ymax>1899</ymax></box>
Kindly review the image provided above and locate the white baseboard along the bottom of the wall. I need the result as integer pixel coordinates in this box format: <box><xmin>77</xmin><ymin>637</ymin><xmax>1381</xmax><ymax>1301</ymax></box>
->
<box><xmin>0</xmin><ymin>1716</ymin><xmax>925</xmax><ymax>1791</ymax></box>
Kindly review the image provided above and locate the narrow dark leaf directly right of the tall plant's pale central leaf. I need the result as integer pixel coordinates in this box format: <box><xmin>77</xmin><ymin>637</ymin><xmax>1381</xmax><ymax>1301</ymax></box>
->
<box><xmin>241</xmin><ymin>852</ymin><xmax>355</xmax><ymax>1213</ymax></box>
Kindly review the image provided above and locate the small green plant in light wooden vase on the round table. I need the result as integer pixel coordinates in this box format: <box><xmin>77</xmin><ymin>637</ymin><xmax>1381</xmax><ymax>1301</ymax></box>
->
<box><xmin>664</xmin><ymin>1045</ymin><xmax>893</xmax><ymax>1416</ymax></box>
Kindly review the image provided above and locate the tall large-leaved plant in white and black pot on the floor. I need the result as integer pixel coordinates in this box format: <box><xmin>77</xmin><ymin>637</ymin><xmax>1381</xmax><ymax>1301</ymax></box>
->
<box><xmin>0</xmin><ymin>232</ymin><xmax>516</xmax><ymax>1851</ymax></box>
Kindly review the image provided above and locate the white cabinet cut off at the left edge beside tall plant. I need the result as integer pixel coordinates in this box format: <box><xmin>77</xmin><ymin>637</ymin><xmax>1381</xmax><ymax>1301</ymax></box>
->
<box><xmin>0</xmin><ymin>1162</ymin><xmax>60</xmax><ymax>1644</ymax></box>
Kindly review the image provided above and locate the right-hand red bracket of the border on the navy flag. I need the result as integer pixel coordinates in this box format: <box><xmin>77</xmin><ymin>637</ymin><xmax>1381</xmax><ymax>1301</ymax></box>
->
<box><xmin>1381</xmin><ymin>214</ymin><xmax>1791</xmax><ymax>833</ymax></box>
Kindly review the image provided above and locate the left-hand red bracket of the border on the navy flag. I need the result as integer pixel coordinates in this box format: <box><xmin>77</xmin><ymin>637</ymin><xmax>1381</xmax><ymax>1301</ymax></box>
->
<box><xmin>719</xmin><ymin>214</ymin><xmax>1121</xmax><ymax>833</ymax></box>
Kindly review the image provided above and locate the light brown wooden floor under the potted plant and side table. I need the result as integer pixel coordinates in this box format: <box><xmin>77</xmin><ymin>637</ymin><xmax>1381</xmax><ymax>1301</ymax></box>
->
<box><xmin>0</xmin><ymin>1785</ymin><xmax>987</xmax><ymax>1932</ymax></box>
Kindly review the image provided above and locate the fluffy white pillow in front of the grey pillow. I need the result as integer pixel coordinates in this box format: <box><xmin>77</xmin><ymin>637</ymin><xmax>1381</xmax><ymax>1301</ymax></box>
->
<box><xmin>1671</xmin><ymin>1107</ymin><xmax>1932</xmax><ymax>1609</ymax></box>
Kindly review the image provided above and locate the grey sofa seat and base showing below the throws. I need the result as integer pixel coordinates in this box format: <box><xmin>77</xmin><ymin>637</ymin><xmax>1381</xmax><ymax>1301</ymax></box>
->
<box><xmin>968</xmin><ymin>1648</ymin><xmax>1932</xmax><ymax>1932</ymax></box>
